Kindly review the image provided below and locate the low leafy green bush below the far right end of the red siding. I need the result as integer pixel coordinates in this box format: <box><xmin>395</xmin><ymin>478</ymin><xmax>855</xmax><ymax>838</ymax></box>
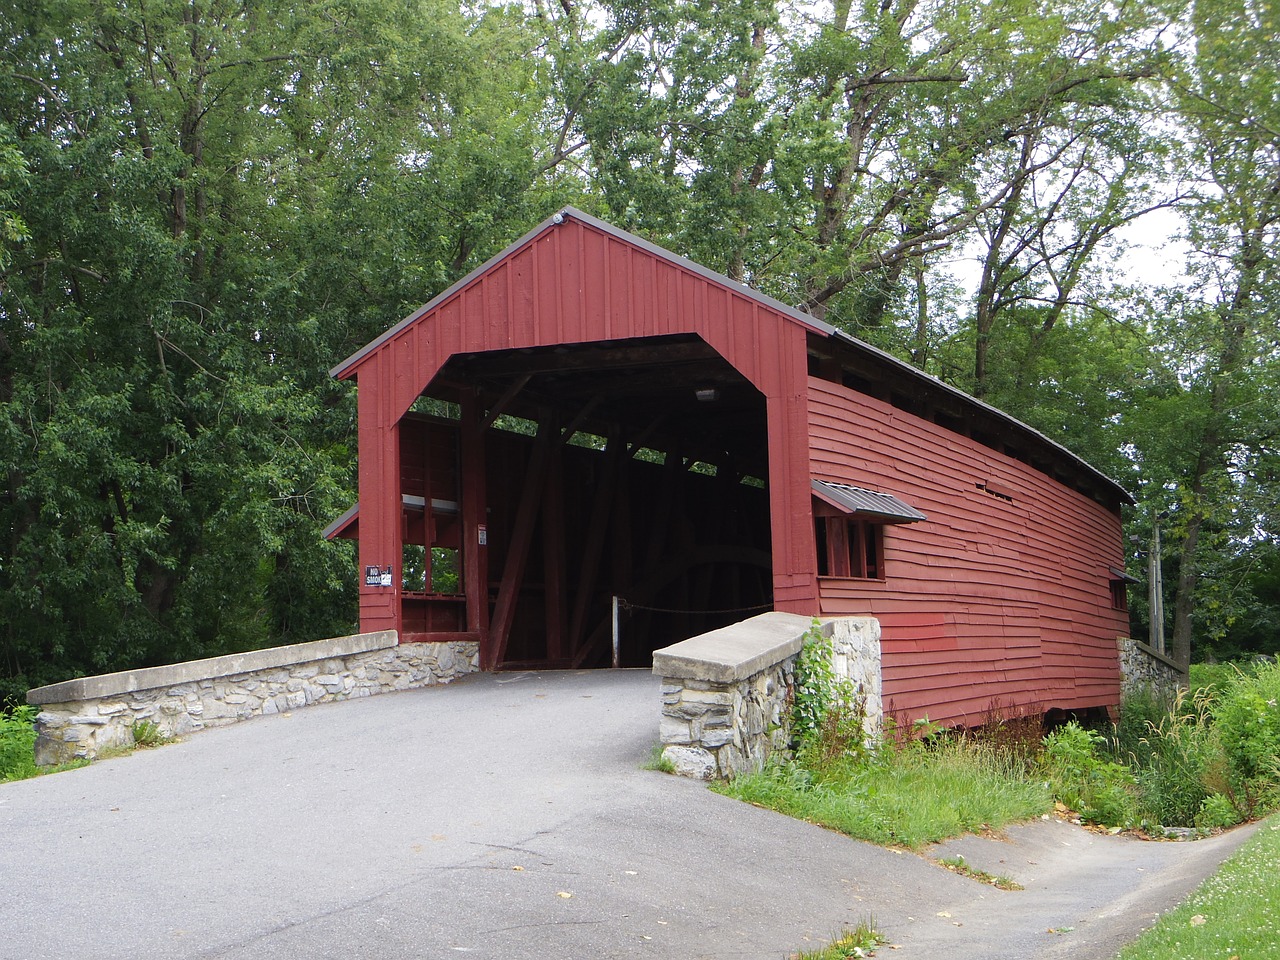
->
<box><xmin>1041</xmin><ymin>721</ymin><xmax>1138</xmax><ymax>827</ymax></box>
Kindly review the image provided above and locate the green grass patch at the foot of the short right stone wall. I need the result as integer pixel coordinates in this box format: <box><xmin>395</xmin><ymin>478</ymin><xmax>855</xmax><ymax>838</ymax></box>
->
<box><xmin>714</xmin><ymin>737</ymin><xmax>1052</xmax><ymax>850</ymax></box>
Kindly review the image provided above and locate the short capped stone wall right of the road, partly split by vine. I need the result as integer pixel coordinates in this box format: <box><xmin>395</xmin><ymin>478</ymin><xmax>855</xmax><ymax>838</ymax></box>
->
<box><xmin>653</xmin><ymin>613</ymin><xmax>882</xmax><ymax>780</ymax></box>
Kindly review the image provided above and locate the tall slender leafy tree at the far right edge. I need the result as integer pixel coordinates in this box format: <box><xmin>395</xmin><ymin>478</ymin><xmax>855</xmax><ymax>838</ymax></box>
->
<box><xmin>1171</xmin><ymin>0</ymin><xmax>1280</xmax><ymax>663</ymax></box>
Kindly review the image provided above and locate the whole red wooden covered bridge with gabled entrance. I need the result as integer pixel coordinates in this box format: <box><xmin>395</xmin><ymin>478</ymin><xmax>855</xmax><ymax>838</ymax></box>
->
<box><xmin>329</xmin><ymin>209</ymin><xmax>1128</xmax><ymax>722</ymax></box>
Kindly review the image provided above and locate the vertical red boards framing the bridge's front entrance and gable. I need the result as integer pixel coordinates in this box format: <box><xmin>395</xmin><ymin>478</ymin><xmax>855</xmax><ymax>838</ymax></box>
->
<box><xmin>348</xmin><ymin>218</ymin><xmax>818</xmax><ymax>642</ymax></box>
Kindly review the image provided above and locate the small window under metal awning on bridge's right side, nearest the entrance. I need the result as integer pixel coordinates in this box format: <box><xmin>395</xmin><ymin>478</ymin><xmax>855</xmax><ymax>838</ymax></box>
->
<box><xmin>812</xmin><ymin>480</ymin><xmax>928</xmax><ymax>580</ymax></box>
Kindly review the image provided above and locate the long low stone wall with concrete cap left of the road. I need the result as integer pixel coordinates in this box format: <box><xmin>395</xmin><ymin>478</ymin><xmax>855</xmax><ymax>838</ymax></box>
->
<box><xmin>27</xmin><ymin>630</ymin><xmax>480</xmax><ymax>765</ymax></box>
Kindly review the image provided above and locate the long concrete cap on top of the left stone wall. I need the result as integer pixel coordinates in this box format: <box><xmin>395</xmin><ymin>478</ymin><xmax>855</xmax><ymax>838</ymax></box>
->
<box><xmin>27</xmin><ymin>630</ymin><xmax>398</xmax><ymax>705</ymax></box>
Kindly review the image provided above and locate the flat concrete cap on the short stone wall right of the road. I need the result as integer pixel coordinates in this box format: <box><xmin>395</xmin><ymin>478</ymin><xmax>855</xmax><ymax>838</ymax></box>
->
<box><xmin>653</xmin><ymin>612</ymin><xmax>813</xmax><ymax>684</ymax></box>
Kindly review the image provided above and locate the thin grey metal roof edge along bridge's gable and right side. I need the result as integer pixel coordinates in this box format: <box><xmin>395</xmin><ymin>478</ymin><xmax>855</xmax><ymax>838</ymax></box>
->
<box><xmin>329</xmin><ymin>206</ymin><xmax>1134</xmax><ymax>503</ymax></box>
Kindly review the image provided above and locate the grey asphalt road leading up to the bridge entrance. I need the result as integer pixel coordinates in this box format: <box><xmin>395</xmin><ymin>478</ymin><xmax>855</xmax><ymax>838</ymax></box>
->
<box><xmin>0</xmin><ymin>671</ymin><xmax>1245</xmax><ymax>960</ymax></box>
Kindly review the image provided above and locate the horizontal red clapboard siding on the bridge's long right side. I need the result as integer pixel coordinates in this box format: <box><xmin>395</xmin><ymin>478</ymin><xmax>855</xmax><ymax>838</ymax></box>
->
<box><xmin>808</xmin><ymin>378</ymin><xmax>1128</xmax><ymax>723</ymax></box>
